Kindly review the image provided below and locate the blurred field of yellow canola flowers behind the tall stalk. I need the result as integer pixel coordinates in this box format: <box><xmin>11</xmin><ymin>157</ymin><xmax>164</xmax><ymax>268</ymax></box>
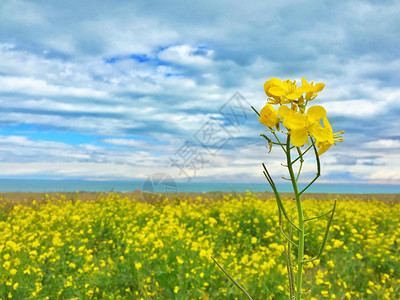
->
<box><xmin>0</xmin><ymin>193</ymin><xmax>400</xmax><ymax>300</ymax></box>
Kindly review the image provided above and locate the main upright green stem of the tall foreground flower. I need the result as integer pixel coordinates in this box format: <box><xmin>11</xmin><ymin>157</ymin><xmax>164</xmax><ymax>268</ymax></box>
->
<box><xmin>286</xmin><ymin>135</ymin><xmax>304</xmax><ymax>300</ymax></box>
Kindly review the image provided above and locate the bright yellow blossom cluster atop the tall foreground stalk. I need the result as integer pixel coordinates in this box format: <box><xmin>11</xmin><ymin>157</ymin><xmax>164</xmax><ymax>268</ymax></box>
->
<box><xmin>259</xmin><ymin>78</ymin><xmax>344</xmax><ymax>155</ymax></box>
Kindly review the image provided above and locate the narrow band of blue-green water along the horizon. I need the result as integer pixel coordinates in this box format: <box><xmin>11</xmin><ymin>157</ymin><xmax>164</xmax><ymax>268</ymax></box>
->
<box><xmin>0</xmin><ymin>179</ymin><xmax>400</xmax><ymax>194</ymax></box>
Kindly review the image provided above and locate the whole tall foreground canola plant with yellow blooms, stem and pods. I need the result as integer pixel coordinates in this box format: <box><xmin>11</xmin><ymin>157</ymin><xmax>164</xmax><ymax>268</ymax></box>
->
<box><xmin>212</xmin><ymin>78</ymin><xmax>344</xmax><ymax>300</ymax></box>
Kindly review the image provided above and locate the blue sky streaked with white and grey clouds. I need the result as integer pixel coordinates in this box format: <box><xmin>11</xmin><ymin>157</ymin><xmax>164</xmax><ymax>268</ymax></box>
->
<box><xmin>0</xmin><ymin>0</ymin><xmax>400</xmax><ymax>184</ymax></box>
